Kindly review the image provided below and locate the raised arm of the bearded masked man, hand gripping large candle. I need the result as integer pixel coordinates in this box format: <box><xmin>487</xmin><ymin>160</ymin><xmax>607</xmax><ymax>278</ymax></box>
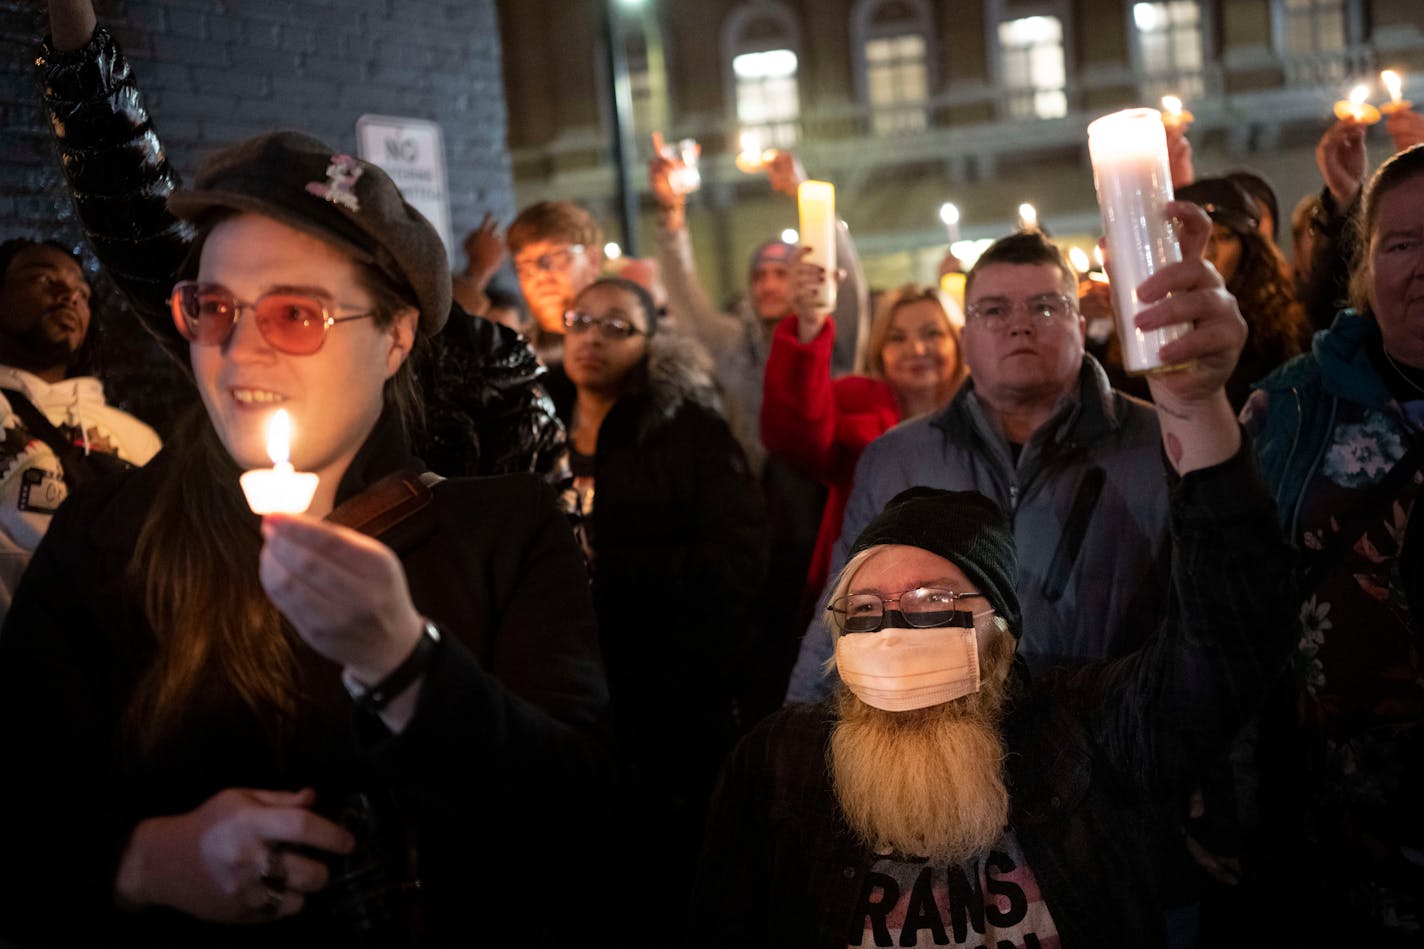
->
<box><xmin>1059</xmin><ymin>202</ymin><xmax>1294</xmax><ymax>795</ymax></box>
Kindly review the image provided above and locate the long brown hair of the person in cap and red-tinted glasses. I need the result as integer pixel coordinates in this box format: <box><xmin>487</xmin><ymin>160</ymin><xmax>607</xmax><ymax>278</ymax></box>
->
<box><xmin>124</xmin><ymin>221</ymin><xmax>423</xmax><ymax>754</ymax></box>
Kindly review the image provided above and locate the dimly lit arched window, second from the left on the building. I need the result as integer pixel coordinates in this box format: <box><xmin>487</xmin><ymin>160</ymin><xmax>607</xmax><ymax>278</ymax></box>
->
<box><xmin>850</xmin><ymin>0</ymin><xmax>934</xmax><ymax>135</ymax></box>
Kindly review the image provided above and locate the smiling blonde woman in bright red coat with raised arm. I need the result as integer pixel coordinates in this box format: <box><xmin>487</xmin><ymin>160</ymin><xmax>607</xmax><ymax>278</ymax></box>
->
<box><xmin>762</xmin><ymin>277</ymin><xmax>967</xmax><ymax>596</ymax></box>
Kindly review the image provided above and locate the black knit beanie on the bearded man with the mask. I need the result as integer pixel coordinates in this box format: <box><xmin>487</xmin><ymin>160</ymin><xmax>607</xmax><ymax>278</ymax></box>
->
<box><xmin>850</xmin><ymin>487</ymin><xmax>1021</xmax><ymax>637</ymax></box>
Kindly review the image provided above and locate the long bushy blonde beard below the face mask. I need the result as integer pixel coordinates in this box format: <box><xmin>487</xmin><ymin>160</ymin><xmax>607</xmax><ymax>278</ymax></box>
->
<box><xmin>830</xmin><ymin>634</ymin><xmax>1014</xmax><ymax>864</ymax></box>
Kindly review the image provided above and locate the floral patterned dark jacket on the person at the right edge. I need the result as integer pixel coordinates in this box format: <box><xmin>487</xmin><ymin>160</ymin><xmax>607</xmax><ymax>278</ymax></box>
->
<box><xmin>1242</xmin><ymin>311</ymin><xmax>1424</xmax><ymax>935</ymax></box>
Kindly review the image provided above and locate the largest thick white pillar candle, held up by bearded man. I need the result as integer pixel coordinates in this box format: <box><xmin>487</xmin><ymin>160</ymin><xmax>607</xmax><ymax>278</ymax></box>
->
<box><xmin>1088</xmin><ymin>108</ymin><xmax>1190</xmax><ymax>375</ymax></box>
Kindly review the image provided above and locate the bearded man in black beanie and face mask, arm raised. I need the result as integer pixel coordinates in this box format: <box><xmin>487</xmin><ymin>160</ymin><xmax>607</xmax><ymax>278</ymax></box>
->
<box><xmin>693</xmin><ymin>202</ymin><xmax>1292</xmax><ymax>949</ymax></box>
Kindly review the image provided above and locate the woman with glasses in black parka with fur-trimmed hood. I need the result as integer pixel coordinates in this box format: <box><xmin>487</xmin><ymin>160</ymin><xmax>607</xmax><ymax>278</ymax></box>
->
<box><xmin>550</xmin><ymin>278</ymin><xmax>766</xmax><ymax>923</ymax></box>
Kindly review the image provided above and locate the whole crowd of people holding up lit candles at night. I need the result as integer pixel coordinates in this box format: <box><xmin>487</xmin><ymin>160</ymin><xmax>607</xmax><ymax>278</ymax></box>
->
<box><xmin>0</xmin><ymin>0</ymin><xmax>1424</xmax><ymax>949</ymax></box>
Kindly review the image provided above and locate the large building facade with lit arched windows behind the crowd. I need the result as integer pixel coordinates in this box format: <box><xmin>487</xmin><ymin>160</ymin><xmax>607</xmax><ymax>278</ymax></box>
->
<box><xmin>498</xmin><ymin>0</ymin><xmax>1424</xmax><ymax>294</ymax></box>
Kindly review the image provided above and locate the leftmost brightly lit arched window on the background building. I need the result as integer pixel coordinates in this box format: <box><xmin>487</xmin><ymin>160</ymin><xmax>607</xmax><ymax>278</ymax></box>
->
<box><xmin>722</xmin><ymin>1</ymin><xmax>800</xmax><ymax>148</ymax></box>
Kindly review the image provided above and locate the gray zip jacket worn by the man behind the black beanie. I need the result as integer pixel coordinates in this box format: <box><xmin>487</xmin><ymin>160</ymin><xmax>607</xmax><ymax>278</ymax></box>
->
<box><xmin>786</xmin><ymin>356</ymin><xmax>1169</xmax><ymax>701</ymax></box>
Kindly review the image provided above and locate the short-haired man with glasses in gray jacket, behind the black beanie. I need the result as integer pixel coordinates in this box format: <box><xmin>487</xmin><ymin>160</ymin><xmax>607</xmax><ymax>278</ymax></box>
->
<box><xmin>786</xmin><ymin>231</ymin><xmax>1168</xmax><ymax>701</ymax></box>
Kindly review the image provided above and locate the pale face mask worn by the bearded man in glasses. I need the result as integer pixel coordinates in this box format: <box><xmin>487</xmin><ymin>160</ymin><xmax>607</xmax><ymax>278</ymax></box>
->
<box><xmin>836</xmin><ymin>626</ymin><xmax>980</xmax><ymax>711</ymax></box>
